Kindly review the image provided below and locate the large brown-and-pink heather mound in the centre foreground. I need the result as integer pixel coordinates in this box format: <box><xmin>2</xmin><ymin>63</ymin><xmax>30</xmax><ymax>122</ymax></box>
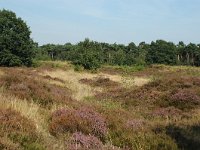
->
<box><xmin>50</xmin><ymin>107</ymin><xmax>107</xmax><ymax>137</ymax></box>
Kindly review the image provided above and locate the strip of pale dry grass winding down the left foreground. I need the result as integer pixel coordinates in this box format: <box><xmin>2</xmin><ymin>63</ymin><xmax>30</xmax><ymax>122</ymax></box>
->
<box><xmin>0</xmin><ymin>88</ymin><xmax>64</xmax><ymax>150</ymax></box>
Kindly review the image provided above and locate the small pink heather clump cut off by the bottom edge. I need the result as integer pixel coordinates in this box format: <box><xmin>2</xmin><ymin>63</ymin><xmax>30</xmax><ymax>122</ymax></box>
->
<box><xmin>66</xmin><ymin>132</ymin><xmax>103</xmax><ymax>150</ymax></box>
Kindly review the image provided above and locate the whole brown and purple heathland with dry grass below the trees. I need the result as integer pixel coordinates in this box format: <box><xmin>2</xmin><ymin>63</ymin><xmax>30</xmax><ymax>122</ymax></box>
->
<box><xmin>0</xmin><ymin>61</ymin><xmax>200</xmax><ymax>150</ymax></box>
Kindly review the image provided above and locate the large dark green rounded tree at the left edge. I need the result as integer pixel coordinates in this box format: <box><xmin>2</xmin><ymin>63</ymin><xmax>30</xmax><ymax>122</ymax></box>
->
<box><xmin>0</xmin><ymin>10</ymin><xmax>34</xmax><ymax>67</ymax></box>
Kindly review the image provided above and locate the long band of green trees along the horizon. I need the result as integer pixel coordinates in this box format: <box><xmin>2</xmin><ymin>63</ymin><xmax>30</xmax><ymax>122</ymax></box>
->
<box><xmin>36</xmin><ymin>39</ymin><xmax>200</xmax><ymax>69</ymax></box>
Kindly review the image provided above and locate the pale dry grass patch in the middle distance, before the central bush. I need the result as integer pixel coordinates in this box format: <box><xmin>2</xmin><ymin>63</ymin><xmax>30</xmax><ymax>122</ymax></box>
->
<box><xmin>40</xmin><ymin>69</ymin><xmax>150</xmax><ymax>100</ymax></box>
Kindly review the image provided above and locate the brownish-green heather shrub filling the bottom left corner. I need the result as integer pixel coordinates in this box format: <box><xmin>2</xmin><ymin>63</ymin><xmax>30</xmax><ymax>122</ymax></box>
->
<box><xmin>0</xmin><ymin>109</ymin><xmax>43</xmax><ymax>149</ymax></box>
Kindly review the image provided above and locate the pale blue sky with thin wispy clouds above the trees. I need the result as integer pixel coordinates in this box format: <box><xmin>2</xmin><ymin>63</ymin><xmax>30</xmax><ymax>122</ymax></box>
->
<box><xmin>0</xmin><ymin>0</ymin><xmax>200</xmax><ymax>45</ymax></box>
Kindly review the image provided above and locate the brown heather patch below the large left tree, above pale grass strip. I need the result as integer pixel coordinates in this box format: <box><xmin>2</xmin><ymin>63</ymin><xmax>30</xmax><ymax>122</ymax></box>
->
<box><xmin>0</xmin><ymin>69</ymin><xmax>73</xmax><ymax>107</ymax></box>
